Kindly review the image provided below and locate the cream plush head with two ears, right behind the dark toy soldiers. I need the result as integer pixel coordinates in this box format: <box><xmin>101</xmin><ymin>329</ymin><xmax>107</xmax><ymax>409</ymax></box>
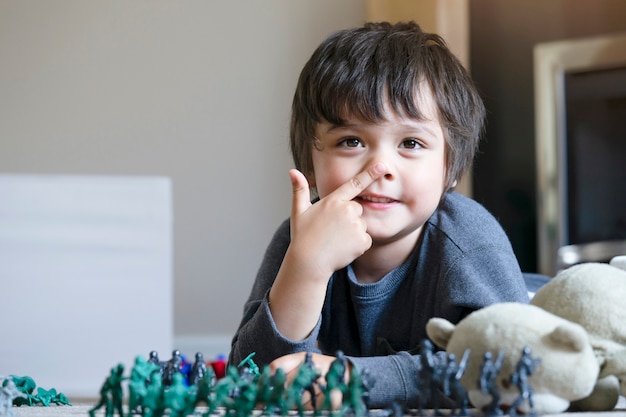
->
<box><xmin>426</xmin><ymin>303</ymin><xmax>599</xmax><ymax>415</ymax></box>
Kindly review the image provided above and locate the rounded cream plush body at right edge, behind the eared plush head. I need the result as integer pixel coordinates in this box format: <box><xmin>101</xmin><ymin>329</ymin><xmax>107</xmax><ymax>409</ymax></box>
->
<box><xmin>531</xmin><ymin>256</ymin><xmax>626</xmax><ymax>411</ymax></box>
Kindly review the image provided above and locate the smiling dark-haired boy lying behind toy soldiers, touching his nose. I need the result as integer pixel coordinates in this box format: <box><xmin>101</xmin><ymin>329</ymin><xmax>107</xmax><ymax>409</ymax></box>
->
<box><xmin>230</xmin><ymin>22</ymin><xmax>528</xmax><ymax>408</ymax></box>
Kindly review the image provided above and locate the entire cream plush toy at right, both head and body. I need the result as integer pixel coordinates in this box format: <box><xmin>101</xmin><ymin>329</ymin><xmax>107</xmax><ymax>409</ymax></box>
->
<box><xmin>426</xmin><ymin>257</ymin><xmax>626</xmax><ymax>414</ymax></box>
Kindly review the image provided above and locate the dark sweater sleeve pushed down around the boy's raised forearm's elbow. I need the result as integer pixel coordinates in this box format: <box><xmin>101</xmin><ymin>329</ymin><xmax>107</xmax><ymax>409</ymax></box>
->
<box><xmin>228</xmin><ymin>220</ymin><xmax>320</xmax><ymax>366</ymax></box>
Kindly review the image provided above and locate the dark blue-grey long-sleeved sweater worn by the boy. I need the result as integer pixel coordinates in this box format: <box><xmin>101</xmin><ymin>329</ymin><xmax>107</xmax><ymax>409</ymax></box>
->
<box><xmin>229</xmin><ymin>192</ymin><xmax>528</xmax><ymax>408</ymax></box>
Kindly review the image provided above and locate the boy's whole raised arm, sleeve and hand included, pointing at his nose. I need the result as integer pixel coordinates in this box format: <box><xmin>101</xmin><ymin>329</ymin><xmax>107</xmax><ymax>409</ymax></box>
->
<box><xmin>229</xmin><ymin>164</ymin><xmax>385</xmax><ymax>364</ymax></box>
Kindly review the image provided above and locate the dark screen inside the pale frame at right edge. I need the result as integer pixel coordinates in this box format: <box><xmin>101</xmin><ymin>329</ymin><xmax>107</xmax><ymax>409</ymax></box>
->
<box><xmin>565</xmin><ymin>68</ymin><xmax>626</xmax><ymax>244</ymax></box>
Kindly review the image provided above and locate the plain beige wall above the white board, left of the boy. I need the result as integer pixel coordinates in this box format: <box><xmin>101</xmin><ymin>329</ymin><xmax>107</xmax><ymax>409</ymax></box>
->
<box><xmin>0</xmin><ymin>0</ymin><xmax>364</xmax><ymax>348</ymax></box>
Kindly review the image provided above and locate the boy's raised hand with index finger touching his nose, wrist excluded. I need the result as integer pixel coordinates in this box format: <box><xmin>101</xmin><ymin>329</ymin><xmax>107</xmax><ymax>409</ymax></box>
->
<box><xmin>289</xmin><ymin>162</ymin><xmax>386</xmax><ymax>277</ymax></box>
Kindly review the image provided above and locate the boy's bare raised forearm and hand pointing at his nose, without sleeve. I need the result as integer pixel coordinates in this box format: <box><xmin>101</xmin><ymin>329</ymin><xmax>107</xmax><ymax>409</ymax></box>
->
<box><xmin>268</xmin><ymin>163</ymin><xmax>386</xmax><ymax>340</ymax></box>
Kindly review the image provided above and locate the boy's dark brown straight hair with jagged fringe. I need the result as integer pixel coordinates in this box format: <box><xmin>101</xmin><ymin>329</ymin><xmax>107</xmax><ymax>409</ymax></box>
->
<box><xmin>290</xmin><ymin>22</ymin><xmax>485</xmax><ymax>189</ymax></box>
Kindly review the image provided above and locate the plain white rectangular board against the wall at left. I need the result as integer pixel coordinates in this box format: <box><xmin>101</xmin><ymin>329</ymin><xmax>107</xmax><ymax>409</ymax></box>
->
<box><xmin>0</xmin><ymin>175</ymin><xmax>173</xmax><ymax>398</ymax></box>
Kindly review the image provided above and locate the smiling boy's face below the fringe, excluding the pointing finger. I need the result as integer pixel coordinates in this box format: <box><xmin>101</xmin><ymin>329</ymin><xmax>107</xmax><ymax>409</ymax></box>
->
<box><xmin>309</xmin><ymin>90</ymin><xmax>446</xmax><ymax>245</ymax></box>
